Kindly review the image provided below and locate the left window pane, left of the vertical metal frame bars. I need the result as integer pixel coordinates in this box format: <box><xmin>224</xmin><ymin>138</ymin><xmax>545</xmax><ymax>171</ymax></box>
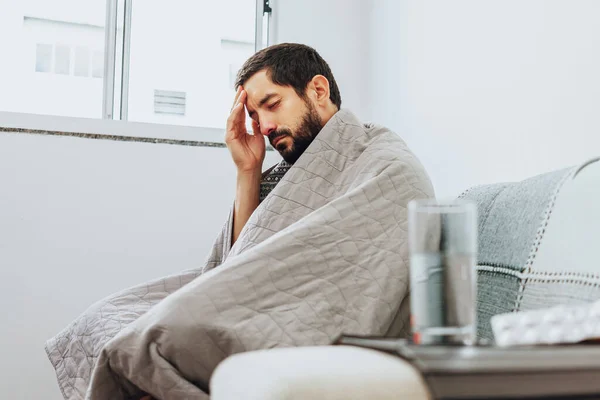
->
<box><xmin>0</xmin><ymin>0</ymin><xmax>106</xmax><ymax>118</ymax></box>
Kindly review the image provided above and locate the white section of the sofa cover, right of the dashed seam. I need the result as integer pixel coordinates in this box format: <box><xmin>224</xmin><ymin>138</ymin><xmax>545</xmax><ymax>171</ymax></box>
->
<box><xmin>517</xmin><ymin>160</ymin><xmax>600</xmax><ymax>311</ymax></box>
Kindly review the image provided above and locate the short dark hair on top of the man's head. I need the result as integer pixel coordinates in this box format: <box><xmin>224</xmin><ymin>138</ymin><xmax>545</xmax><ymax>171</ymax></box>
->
<box><xmin>235</xmin><ymin>43</ymin><xmax>342</xmax><ymax>110</ymax></box>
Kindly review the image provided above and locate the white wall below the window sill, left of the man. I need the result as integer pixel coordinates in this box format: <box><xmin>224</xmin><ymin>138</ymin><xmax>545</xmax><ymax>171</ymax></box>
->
<box><xmin>0</xmin><ymin>126</ymin><xmax>278</xmax><ymax>400</ymax></box>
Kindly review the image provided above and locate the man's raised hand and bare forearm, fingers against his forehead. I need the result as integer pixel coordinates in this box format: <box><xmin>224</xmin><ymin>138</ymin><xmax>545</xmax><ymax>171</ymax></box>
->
<box><xmin>225</xmin><ymin>87</ymin><xmax>266</xmax><ymax>245</ymax></box>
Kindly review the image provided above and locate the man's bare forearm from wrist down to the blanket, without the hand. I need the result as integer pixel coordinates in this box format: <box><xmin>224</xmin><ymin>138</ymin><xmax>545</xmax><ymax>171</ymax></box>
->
<box><xmin>231</xmin><ymin>169</ymin><xmax>261</xmax><ymax>244</ymax></box>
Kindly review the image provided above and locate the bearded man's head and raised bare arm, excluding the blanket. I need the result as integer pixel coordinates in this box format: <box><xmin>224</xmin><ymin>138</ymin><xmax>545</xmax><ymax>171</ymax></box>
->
<box><xmin>225</xmin><ymin>44</ymin><xmax>342</xmax><ymax>250</ymax></box>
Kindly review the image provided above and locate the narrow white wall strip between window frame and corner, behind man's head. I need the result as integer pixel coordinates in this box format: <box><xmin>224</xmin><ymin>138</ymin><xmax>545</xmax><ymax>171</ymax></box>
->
<box><xmin>272</xmin><ymin>0</ymin><xmax>371</xmax><ymax>121</ymax></box>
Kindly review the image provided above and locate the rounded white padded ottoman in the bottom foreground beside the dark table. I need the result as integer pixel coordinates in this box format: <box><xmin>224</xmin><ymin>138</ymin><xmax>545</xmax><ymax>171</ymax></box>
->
<box><xmin>210</xmin><ymin>346</ymin><xmax>430</xmax><ymax>400</ymax></box>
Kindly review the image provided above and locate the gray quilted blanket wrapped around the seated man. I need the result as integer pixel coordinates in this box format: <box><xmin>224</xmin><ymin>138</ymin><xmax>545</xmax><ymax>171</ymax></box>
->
<box><xmin>47</xmin><ymin>110</ymin><xmax>433</xmax><ymax>400</ymax></box>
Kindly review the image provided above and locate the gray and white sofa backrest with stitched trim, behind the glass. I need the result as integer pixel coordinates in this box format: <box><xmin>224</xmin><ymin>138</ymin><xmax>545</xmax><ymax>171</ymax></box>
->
<box><xmin>461</xmin><ymin>159</ymin><xmax>600</xmax><ymax>339</ymax></box>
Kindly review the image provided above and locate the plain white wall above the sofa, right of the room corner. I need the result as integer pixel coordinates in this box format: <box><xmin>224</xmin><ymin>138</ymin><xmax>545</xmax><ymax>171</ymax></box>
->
<box><xmin>369</xmin><ymin>0</ymin><xmax>600</xmax><ymax>196</ymax></box>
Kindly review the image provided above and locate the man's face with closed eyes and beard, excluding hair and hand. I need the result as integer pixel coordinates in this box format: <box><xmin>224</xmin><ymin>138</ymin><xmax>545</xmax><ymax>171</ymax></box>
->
<box><xmin>244</xmin><ymin>71</ymin><xmax>323</xmax><ymax>164</ymax></box>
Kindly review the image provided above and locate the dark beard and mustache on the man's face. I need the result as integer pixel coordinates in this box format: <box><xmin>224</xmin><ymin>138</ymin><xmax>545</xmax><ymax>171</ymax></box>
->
<box><xmin>269</xmin><ymin>102</ymin><xmax>323</xmax><ymax>164</ymax></box>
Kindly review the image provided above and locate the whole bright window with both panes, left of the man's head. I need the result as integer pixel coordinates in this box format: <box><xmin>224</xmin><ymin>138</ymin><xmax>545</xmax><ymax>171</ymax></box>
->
<box><xmin>0</xmin><ymin>0</ymin><xmax>268</xmax><ymax>128</ymax></box>
